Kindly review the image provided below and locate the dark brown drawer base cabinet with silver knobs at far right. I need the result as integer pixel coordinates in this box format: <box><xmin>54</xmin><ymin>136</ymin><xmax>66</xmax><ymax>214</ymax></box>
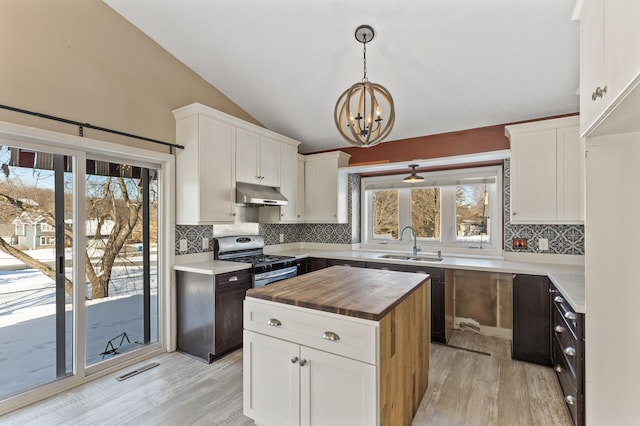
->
<box><xmin>551</xmin><ymin>286</ymin><xmax>585</xmax><ymax>426</ymax></box>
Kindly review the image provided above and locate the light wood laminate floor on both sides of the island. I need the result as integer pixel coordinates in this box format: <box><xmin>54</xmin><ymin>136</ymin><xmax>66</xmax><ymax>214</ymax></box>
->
<box><xmin>0</xmin><ymin>331</ymin><xmax>571</xmax><ymax>426</ymax></box>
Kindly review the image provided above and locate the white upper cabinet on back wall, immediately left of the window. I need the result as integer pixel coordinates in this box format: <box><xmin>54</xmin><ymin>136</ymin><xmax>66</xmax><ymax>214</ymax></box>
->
<box><xmin>304</xmin><ymin>151</ymin><xmax>351</xmax><ymax>223</ymax></box>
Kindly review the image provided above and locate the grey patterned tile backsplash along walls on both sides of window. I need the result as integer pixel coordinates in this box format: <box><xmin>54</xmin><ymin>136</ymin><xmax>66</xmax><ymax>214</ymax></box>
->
<box><xmin>175</xmin><ymin>159</ymin><xmax>584</xmax><ymax>255</ymax></box>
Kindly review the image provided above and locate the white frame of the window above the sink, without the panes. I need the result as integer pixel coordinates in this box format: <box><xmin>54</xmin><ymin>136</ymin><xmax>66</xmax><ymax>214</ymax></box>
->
<box><xmin>360</xmin><ymin>165</ymin><xmax>504</xmax><ymax>256</ymax></box>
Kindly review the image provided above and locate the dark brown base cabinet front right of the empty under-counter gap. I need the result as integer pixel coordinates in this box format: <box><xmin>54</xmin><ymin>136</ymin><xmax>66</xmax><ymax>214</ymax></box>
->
<box><xmin>511</xmin><ymin>274</ymin><xmax>551</xmax><ymax>366</ymax></box>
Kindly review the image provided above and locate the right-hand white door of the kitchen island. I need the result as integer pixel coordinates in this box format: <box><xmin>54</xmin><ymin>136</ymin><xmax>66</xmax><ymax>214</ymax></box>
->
<box><xmin>300</xmin><ymin>346</ymin><xmax>379</xmax><ymax>426</ymax></box>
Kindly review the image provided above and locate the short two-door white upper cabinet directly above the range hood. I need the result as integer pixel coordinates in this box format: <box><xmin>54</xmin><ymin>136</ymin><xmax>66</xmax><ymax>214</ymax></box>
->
<box><xmin>236</xmin><ymin>128</ymin><xmax>280</xmax><ymax>186</ymax></box>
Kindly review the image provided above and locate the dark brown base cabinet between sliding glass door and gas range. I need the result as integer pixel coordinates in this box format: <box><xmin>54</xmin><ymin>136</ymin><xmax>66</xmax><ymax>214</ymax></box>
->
<box><xmin>176</xmin><ymin>270</ymin><xmax>251</xmax><ymax>363</ymax></box>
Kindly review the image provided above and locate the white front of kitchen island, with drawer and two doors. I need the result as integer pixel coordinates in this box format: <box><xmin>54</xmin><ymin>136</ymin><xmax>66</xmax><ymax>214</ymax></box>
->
<box><xmin>244</xmin><ymin>299</ymin><xmax>377</xmax><ymax>425</ymax></box>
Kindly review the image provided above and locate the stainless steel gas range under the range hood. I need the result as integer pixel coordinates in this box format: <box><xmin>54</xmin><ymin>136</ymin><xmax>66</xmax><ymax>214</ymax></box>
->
<box><xmin>213</xmin><ymin>235</ymin><xmax>298</xmax><ymax>287</ymax></box>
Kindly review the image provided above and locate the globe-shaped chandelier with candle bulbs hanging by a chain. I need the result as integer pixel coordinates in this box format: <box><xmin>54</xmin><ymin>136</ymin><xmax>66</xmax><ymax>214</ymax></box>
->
<box><xmin>333</xmin><ymin>25</ymin><xmax>396</xmax><ymax>147</ymax></box>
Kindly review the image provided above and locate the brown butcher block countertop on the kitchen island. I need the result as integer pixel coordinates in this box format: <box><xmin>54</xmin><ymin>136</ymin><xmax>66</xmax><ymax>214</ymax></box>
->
<box><xmin>247</xmin><ymin>266</ymin><xmax>429</xmax><ymax>321</ymax></box>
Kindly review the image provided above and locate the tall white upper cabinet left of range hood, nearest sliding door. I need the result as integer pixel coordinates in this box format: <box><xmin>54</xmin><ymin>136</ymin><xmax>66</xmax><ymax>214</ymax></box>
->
<box><xmin>173</xmin><ymin>104</ymin><xmax>235</xmax><ymax>225</ymax></box>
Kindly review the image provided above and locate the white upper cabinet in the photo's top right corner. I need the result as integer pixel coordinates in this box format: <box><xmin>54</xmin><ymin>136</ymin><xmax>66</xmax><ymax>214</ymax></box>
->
<box><xmin>574</xmin><ymin>0</ymin><xmax>640</xmax><ymax>136</ymax></box>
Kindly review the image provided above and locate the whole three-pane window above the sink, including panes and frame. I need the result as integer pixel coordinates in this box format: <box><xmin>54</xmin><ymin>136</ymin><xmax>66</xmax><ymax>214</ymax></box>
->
<box><xmin>362</xmin><ymin>166</ymin><xmax>502</xmax><ymax>255</ymax></box>
